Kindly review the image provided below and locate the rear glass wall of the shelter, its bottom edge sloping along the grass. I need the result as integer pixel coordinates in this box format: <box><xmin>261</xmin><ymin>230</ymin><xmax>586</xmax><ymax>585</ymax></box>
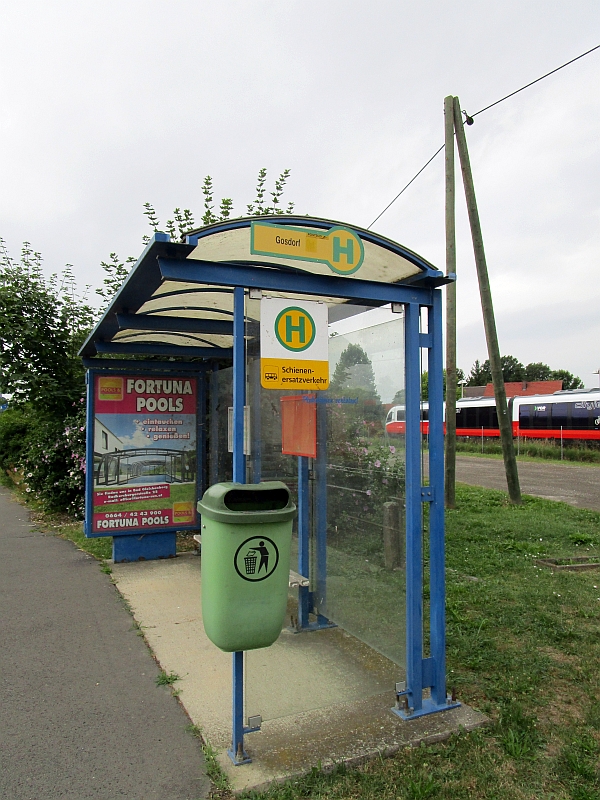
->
<box><xmin>316</xmin><ymin>309</ymin><xmax>405</xmax><ymax>668</ymax></box>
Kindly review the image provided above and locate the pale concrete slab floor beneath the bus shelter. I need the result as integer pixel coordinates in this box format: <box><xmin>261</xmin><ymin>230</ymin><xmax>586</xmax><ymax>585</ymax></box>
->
<box><xmin>113</xmin><ymin>553</ymin><xmax>487</xmax><ymax>792</ymax></box>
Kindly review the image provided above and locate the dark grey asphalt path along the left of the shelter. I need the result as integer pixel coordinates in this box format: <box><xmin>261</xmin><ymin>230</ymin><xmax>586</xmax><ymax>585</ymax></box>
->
<box><xmin>0</xmin><ymin>488</ymin><xmax>209</xmax><ymax>800</ymax></box>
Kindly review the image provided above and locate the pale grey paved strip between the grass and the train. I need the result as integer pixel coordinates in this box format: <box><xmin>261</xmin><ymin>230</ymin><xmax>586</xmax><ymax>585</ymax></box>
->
<box><xmin>456</xmin><ymin>455</ymin><xmax>600</xmax><ymax>511</ymax></box>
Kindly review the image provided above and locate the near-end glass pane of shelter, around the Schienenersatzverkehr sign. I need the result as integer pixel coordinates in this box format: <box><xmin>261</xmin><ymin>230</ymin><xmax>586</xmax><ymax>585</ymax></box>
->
<box><xmin>245</xmin><ymin>301</ymin><xmax>405</xmax><ymax>720</ymax></box>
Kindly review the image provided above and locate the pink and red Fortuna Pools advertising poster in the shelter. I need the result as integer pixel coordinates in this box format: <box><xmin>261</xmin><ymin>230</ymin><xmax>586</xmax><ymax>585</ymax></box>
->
<box><xmin>91</xmin><ymin>374</ymin><xmax>198</xmax><ymax>536</ymax></box>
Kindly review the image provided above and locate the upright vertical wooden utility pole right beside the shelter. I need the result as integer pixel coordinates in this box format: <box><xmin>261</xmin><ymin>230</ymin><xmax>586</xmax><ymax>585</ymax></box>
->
<box><xmin>444</xmin><ymin>96</ymin><xmax>456</xmax><ymax>508</ymax></box>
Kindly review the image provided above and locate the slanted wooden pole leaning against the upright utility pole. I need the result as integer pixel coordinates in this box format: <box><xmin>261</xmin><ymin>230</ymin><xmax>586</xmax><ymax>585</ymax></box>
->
<box><xmin>454</xmin><ymin>97</ymin><xmax>521</xmax><ymax>503</ymax></box>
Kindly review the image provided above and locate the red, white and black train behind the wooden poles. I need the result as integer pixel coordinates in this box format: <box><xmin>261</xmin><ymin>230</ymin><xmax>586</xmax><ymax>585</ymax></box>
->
<box><xmin>385</xmin><ymin>389</ymin><xmax>600</xmax><ymax>440</ymax></box>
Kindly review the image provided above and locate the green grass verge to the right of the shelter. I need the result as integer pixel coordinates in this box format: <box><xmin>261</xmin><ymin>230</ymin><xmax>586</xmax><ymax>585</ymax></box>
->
<box><xmin>239</xmin><ymin>487</ymin><xmax>600</xmax><ymax>800</ymax></box>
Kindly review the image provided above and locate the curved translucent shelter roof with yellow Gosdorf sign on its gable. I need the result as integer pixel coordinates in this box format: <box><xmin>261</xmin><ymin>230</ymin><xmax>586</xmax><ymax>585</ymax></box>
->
<box><xmin>80</xmin><ymin>216</ymin><xmax>448</xmax><ymax>358</ymax></box>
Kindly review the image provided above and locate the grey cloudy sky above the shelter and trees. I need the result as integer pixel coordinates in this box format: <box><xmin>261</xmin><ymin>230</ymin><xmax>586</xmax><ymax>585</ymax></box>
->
<box><xmin>0</xmin><ymin>0</ymin><xmax>600</xmax><ymax>386</ymax></box>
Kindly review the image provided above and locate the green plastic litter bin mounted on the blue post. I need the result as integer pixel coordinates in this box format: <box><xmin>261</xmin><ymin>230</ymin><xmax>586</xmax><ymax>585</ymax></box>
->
<box><xmin>198</xmin><ymin>481</ymin><xmax>296</xmax><ymax>653</ymax></box>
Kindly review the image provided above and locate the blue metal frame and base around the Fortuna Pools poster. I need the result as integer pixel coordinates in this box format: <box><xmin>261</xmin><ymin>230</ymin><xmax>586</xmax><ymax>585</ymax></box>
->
<box><xmin>84</xmin><ymin>368</ymin><xmax>203</xmax><ymax>561</ymax></box>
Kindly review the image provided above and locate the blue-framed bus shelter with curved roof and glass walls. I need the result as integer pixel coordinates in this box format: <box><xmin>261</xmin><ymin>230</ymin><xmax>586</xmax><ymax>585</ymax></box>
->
<box><xmin>80</xmin><ymin>216</ymin><xmax>457</xmax><ymax>764</ymax></box>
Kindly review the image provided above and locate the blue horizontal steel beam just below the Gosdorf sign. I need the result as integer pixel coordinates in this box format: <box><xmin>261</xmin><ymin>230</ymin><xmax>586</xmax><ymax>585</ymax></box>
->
<box><xmin>158</xmin><ymin>258</ymin><xmax>432</xmax><ymax>305</ymax></box>
